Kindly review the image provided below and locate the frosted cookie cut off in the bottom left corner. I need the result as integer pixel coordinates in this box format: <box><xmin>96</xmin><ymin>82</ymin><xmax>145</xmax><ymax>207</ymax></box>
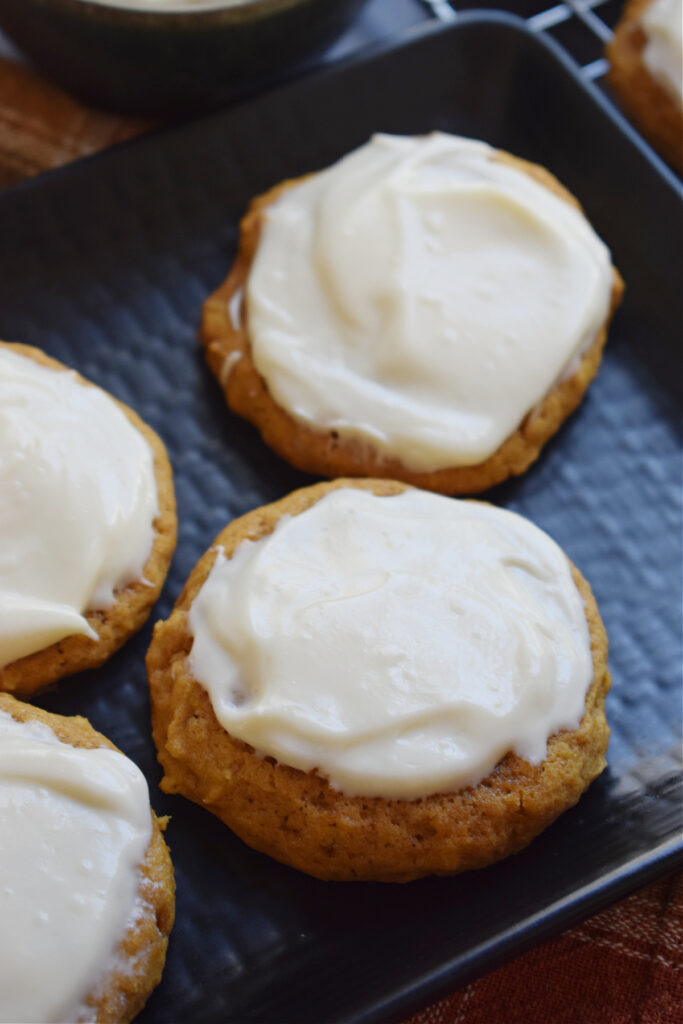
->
<box><xmin>0</xmin><ymin>693</ymin><xmax>174</xmax><ymax>1024</ymax></box>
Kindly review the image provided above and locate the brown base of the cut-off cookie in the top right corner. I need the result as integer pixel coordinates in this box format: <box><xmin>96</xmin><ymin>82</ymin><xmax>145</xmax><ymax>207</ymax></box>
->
<box><xmin>605</xmin><ymin>0</ymin><xmax>683</xmax><ymax>173</ymax></box>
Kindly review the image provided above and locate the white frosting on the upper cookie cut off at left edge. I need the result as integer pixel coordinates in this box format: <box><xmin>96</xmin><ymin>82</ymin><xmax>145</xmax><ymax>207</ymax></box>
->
<box><xmin>0</xmin><ymin>348</ymin><xmax>159</xmax><ymax>668</ymax></box>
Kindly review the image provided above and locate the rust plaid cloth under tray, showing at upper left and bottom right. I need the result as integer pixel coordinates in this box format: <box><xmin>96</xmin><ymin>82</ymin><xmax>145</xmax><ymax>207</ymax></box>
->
<box><xmin>0</xmin><ymin>48</ymin><xmax>683</xmax><ymax>1024</ymax></box>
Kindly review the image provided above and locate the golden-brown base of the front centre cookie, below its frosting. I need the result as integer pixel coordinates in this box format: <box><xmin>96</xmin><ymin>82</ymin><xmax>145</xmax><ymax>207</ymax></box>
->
<box><xmin>147</xmin><ymin>480</ymin><xmax>609</xmax><ymax>882</ymax></box>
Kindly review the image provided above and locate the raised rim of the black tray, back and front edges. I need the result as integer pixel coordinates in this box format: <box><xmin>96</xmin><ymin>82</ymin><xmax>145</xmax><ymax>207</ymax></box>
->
<box><xmin>0</xmin><ymin>10</ymin><xmax>683</xmax><ymax>1024</ymax></box>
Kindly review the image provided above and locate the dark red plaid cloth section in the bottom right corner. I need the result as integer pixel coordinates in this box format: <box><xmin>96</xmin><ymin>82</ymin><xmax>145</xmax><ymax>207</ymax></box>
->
<box><xmin>410</xmin><ymin>873</ymin><xmax>683</xmax><ymax>1024</ymax></box>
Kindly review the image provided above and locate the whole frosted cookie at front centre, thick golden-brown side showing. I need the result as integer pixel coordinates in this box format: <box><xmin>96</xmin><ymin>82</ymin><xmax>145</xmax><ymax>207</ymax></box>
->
<box><xmin>147</xmin><ymin>480</ymin><xmax>609</xmax><ymax>881</ymax></box>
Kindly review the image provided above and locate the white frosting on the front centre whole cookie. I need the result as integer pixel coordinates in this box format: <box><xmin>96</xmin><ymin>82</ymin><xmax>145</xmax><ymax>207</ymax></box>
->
<box><xmin>188</xmin><ymin>487</ymin><xmax>593</xmax><ymax>799</ymax></box>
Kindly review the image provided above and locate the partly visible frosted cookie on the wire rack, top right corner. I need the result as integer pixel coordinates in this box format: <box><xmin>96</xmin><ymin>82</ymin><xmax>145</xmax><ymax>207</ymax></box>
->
<box><xmin>606</xmin><ymin>0</ymin><xmax>683</xmax><ymax>172</ymax></box>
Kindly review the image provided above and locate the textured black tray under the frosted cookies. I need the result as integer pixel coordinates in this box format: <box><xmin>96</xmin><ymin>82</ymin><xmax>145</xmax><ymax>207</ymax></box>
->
<box><xmin>0</xmin><ymin>15</ymin><xmax>681</xmax><ymax>1024</ymax></box>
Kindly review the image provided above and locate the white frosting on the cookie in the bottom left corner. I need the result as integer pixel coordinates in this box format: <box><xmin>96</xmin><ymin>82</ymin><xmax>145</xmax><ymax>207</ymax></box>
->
<box><xmin>0</xmin><ymin>712</ymin><xmax>152</xmax><ymax>1024</ymax></box>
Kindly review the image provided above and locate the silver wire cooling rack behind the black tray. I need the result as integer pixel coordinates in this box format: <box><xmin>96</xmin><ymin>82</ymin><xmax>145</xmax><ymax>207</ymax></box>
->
<box><xmin>423</xmin><ymin>0</ymin><xmax>624</xmax><ymax>81</ymax></box>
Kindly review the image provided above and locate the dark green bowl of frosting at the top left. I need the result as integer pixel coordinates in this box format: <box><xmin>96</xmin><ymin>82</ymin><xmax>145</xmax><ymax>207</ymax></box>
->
<box><xmin>0</xmin><ymin>0</ymin><xmax>364</xmax><ymax>114</ymax></box>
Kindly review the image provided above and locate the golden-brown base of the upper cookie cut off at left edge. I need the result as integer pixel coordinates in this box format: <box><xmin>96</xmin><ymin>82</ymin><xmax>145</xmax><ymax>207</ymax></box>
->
<box><xmin>0</xmin><ymin>341</ymin><xmax>177</xmax><ymax>696</ymax></box>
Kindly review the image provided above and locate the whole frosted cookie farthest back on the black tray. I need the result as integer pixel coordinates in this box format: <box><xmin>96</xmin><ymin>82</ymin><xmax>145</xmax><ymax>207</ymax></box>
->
<box><xmin>202</xmin><ymin>133</ymin><xmax>623</xmax><ymax>494</ymax></box>
